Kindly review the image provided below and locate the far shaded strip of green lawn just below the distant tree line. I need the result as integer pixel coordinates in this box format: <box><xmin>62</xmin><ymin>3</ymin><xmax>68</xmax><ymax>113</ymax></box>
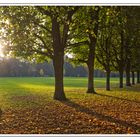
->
<box><xmin>0</xmin><ymin>77</ymin><xmax>119</xmax><ymax>87</ymax></box>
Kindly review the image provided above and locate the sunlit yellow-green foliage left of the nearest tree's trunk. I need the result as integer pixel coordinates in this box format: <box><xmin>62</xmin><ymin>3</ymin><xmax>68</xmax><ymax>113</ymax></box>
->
<box><xmin>1</xmin><ymin>6</ymin><xmax>51</xmax><ymax>60</ymax></box>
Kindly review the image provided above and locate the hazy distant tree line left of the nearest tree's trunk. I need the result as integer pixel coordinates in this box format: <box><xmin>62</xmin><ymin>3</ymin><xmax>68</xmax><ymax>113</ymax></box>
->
<box><xmin>0</xmin><ymin>58</ymin><xmax>54</xmax><ymax>77</ymax></box>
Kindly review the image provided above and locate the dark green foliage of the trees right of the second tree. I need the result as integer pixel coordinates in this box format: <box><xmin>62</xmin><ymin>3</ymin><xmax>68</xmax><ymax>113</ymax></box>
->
<box><xmin>96</xmin><ymin>6</ymin><xmax>139</xmax><ymax>71</ymax></box>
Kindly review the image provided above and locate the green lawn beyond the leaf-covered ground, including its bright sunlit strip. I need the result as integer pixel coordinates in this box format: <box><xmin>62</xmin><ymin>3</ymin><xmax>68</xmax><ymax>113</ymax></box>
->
<box><xmin>0</xmin><ymin>77</ymin><xmax>137</xmax><ymax>107</ymax></box>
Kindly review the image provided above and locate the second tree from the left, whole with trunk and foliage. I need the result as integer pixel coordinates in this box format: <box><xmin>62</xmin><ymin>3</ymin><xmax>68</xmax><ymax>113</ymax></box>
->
<box><xmin>66</xmin><ymin>6</ymin><xmax>100</xmax><ymax>93</ymax></box>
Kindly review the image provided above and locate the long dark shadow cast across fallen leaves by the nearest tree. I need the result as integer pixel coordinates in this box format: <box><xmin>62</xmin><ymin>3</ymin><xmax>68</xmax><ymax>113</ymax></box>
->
<box><xmin>62</xmin><ymin>100</ymin><xmax>140</xmax><ymax>131</ymax></box>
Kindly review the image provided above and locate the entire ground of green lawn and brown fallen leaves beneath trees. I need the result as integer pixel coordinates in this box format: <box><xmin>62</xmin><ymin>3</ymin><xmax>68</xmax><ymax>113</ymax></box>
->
<box><xmin>0</xmin><ymin>77</ymin><xmax>140</xmax><ymax>134</ymax></box>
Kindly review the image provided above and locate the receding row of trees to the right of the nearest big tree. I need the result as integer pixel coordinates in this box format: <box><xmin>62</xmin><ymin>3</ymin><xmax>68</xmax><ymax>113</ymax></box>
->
<box><xmin>67</xmin><ymin>7</ymin><xmax>140</xmax><ymax>93</ymax></box>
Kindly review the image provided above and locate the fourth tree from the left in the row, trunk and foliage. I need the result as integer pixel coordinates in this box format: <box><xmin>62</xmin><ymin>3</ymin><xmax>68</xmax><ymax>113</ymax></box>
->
<box><xmin>107</xmin><ymin>7</ymin><xmax>126</xmax><ymax>88</ymax></box>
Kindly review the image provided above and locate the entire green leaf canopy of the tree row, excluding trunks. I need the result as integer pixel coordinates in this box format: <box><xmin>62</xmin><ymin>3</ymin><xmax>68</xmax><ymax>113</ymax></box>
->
<box><xmin>0</xmin><ymin>6</ymin><xmax>140</xmax><ymax>71</ymax></box>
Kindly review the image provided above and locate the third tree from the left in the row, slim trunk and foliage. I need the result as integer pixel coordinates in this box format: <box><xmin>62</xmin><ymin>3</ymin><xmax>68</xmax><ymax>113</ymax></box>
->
<box><xmin>96</xmin><ymin>7</ymin><xmax>114</xmax><ymax>90</ymax></box>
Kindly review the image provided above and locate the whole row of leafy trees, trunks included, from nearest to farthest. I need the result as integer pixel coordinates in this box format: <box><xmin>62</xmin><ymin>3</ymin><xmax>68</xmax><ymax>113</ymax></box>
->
<box><xmin>0</xmin><ymin>6</ymin><xmax>140</xmax><ymax>100</ymax></box>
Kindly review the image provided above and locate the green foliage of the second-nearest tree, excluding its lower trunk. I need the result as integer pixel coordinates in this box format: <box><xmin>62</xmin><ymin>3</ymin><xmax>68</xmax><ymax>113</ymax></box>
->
<box><xmin>68</xmin><ymin>6</ymin><xmax>100</xmax><ymax>64</ymax></box>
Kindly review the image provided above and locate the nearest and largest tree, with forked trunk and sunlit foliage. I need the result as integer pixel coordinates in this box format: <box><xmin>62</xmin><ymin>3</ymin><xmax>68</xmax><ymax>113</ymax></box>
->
<box><xmin>1</xmin><ymin>6</ymin><xmax>80</xmax><ymax>100</ymax></box>
